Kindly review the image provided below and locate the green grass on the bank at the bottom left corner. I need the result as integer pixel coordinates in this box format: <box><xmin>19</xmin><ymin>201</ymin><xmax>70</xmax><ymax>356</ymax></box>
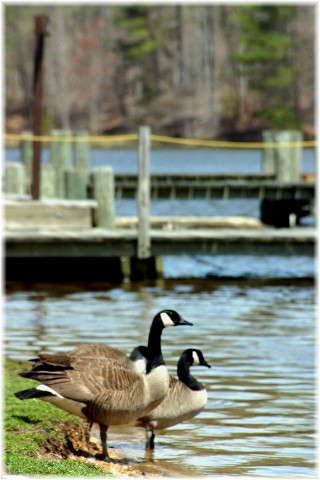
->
<box><xmin>3</xmin><ymin>360</ymin><xmax>107</xmax><ymax>477</ymax></box>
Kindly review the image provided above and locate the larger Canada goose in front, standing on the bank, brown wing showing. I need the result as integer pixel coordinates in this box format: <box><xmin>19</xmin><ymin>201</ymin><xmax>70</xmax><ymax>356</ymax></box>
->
<box><xmin>15</xmin><ymin>310</ymin><xmax>192</xmax><ymax>461</ymax></box>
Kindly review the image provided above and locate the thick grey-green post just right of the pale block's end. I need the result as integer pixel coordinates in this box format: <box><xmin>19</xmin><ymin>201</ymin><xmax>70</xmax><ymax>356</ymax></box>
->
<box><xmin>92</xmin><ymin>167</ymin><xmax>115</xmax><ymax>228</ymax></box>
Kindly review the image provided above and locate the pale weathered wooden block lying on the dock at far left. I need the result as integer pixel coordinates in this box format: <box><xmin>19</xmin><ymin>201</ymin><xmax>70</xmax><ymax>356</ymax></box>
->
<box><xmin>4</xmin><ymin>200</ymin><xmax>97</xmax><ymax>230</ymax></box>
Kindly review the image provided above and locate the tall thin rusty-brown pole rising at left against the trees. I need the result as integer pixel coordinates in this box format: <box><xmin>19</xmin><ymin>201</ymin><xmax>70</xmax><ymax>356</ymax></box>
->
<box><xmin>31</xmin><ymin>15</ymin><xmax>49</xmax><ymax>200</ymax></box>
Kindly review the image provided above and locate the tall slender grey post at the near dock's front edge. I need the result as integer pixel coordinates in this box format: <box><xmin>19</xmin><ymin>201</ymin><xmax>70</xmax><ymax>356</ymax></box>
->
<box><xmin>137</xmin><ymin>126</ymin><xmax>151</xmax><ymax>259</ymax></box>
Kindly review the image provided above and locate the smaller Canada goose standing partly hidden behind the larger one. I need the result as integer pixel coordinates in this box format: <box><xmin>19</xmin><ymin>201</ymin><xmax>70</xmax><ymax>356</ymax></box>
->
<box><xmin>134</xmin><ymin>348</ymin><xmax>211</xmax><ymax>450</ymax></box>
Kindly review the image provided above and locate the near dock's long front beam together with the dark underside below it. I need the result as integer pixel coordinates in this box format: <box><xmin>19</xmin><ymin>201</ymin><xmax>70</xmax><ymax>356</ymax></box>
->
<box><xmin>5</xmin><ymin>227</ymin><xmax>316</xmax><ymax>282</ymax></box>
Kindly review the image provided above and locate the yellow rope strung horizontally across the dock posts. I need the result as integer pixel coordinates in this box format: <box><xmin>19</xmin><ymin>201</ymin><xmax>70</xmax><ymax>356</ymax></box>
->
<box><xmin>4</xmin><ymin>133</ymin><xmax>317</xmax><ymax>149</ymax></box>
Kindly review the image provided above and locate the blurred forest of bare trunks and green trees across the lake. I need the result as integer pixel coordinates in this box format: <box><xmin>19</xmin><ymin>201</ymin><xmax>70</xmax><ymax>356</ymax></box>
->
<box><xmin>4</xmin><ymin>3</ymin><xmax>316</xmax><ymax>141</ymax></box>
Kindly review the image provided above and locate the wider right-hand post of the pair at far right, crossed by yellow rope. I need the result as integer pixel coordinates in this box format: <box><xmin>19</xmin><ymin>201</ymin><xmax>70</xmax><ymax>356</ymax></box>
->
<box><xmin>275</xmin><ymin>130</ymin><xmax>302</xmax><ymax>183</ymax></box>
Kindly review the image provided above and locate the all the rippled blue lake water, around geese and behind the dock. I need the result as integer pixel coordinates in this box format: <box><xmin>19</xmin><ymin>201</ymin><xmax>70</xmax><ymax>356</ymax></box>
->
<box><xmin>4</xmin><ymin>150</ymin><xmax>316</xmax><ymax>478</ymax></box>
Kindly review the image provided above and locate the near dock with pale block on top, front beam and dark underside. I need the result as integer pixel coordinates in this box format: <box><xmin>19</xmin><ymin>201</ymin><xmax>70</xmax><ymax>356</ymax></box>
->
<box><xmin>4</xmin><ymin>200</ymin><xmax>316</xmax><ymax>281</ymax></box>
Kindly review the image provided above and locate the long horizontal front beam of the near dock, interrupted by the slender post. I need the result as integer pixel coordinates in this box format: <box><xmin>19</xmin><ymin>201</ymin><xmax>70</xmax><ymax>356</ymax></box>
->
<box><xmin>5</xmin><ymin>227</ymin><xmax>316</xmax><ymax>258</ymax></box>
